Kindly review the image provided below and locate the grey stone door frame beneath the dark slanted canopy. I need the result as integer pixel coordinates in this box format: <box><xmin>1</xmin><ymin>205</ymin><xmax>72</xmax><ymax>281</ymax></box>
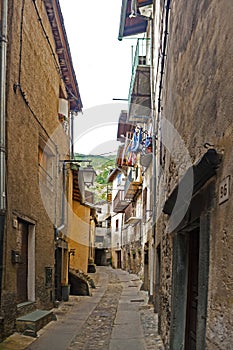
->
<box><xmin>170</xmin><ymin>212</ymin><xmax>210</xmax><ymax>350</ymax></box>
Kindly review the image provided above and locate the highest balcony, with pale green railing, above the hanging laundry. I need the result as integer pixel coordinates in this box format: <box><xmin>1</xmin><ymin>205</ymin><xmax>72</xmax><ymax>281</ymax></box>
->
<box><xmin>128</xmin><ymin>38</ymin><xmax>151</xmax><ymax>123</ymax></box>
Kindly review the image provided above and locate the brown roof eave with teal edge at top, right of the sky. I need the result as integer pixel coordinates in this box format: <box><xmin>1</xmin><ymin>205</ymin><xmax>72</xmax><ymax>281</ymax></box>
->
<box><xmin>118</xmin><ymin>0</ymin><xmax>153</xmax><ymax>40</ymax></box>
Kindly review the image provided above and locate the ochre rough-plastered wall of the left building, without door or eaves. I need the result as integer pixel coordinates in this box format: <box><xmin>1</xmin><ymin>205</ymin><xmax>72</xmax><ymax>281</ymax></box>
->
<box><xmin>1</xmin><ymin>0</ymin><xmax>67</xmax><ymax>335</ymax></box>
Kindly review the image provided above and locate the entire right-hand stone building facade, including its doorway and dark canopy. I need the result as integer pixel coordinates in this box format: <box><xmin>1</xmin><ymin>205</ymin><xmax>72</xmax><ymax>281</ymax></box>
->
<box><xmin>154</xmin><ymin>0</ymin><xmax>233</xmax><ymax>350</ymax></box>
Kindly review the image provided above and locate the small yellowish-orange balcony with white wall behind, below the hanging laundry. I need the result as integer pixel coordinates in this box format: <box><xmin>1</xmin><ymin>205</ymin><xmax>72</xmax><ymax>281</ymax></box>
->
<box><xmin>124</xmin><ymin>167</ymin><xmax>142</xmax><ymax>200</ymax></box>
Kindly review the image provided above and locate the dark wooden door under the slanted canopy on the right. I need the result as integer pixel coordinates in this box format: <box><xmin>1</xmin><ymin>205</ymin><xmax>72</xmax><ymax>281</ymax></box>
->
<box><xmin>185</xmin><ymin>228</ymin><xmax>199</xmax><ymax>350</ymax></box>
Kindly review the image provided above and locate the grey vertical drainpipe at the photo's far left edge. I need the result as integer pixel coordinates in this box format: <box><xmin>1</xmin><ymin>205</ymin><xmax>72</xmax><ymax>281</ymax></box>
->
<box><xmin>0</xmin><ymin>0</ymin><xmax>8</xmax><ymax>300</ymax></box>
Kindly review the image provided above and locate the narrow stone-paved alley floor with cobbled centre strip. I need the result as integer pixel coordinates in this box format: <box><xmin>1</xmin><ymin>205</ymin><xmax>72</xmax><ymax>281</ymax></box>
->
<box><xmin>0</xmin><ymin>267</ymin><xmax>164</xmax><ymax>350</ymax></box>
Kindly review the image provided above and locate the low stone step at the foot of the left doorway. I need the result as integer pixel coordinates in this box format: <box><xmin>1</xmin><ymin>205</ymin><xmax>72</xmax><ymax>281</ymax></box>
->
<box><xmin>16</xmin><ymin>310</ymin><xmax>56</xmax><ymax>337</ymax></box>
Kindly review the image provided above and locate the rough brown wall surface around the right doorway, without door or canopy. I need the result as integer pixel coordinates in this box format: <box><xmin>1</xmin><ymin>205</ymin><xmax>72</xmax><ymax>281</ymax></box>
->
<box><xmin>157</xmin><ymin>0</ymin><xmax>233</xmax><ymax>350</ymax></box>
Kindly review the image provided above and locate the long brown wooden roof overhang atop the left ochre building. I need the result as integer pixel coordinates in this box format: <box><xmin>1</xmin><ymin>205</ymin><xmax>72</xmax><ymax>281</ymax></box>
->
<box><xmin>44</xmin><ymin>0</ymin><xmax>83</xmax><ymax>112</ymax></box>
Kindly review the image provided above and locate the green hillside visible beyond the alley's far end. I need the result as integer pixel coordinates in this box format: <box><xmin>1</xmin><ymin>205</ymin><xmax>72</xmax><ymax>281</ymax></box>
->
<box><xmin>75</xmin><ymin>153</ymin><xmax>116</xmax><ymax>202</ymax></box>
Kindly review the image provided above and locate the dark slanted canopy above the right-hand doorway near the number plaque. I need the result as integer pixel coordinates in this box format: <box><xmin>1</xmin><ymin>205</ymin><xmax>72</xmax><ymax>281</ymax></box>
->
<box><xmin>163</xmin><ymin>149</ymin><xmax>221</xmax><ymax>215</ymax></box>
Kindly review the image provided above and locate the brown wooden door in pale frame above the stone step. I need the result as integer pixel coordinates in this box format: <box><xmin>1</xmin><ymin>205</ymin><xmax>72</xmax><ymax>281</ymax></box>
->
<box><xmin>17</xmin><ymin>222</ymin><xmax>28</xmax><ymax>303</ymax></box>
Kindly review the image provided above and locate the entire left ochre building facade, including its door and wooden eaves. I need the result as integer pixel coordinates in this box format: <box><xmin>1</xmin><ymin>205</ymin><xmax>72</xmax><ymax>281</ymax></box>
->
<box><xmin>0</xmin><ymin>0</ymin><xmax>82</xmax><ymax>339</ymax></box>
